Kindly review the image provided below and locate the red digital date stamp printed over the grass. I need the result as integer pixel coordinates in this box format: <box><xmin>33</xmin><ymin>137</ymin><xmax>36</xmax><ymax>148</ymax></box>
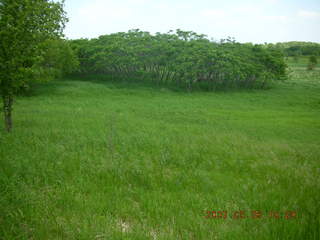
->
<box><xmin>204</xmin><ymin>210</ymin><xmax>298</xmax><ymax>220</ymax></box>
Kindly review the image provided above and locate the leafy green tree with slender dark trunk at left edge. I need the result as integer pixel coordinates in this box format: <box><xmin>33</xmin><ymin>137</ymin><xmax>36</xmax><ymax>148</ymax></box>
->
<box><xmin>0</xmin><ymin>0</ymin><xmax>67</xmax><ymax>132</ymax></box>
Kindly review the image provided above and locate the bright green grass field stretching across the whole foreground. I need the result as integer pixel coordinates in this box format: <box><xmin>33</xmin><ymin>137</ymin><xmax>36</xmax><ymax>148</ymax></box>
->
<box><xmin>0</xmin><ymin>60</ymin><xmax>320</xmax><ymax>240</ymax></box>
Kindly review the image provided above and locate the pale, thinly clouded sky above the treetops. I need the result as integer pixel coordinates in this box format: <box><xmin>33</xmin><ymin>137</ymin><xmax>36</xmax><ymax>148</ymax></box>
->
<box><xmin>65</xmin><ymin>0</ymin><xmax>320</xmax><ymax>43</ymax></box>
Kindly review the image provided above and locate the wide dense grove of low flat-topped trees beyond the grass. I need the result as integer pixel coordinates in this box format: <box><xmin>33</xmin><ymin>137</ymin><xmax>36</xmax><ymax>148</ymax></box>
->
<box><xmin>71</xmin><ymin>30</ymin><xmax>286</xmax><ymax>90</ymax></box>
